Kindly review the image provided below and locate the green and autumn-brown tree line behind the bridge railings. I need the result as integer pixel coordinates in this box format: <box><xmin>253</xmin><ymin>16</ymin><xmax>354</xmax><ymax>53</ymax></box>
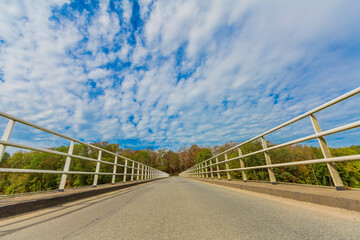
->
<box><xmin>0</xmin><ymin>141</ymin><xmax>360</xmax><ymax>194</ymax></box>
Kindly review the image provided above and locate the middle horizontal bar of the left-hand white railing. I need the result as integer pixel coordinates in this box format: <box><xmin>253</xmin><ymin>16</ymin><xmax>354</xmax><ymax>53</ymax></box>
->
<box><xmin>0</xmin><ymin>140</ymin><xmax>156</xmax><ymax>170</ymax></box>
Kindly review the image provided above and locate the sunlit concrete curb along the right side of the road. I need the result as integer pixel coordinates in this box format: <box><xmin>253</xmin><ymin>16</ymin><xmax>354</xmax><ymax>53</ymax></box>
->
<box><xmin>190</xmin><ymin>178</ymin><xmax>360</xmax><ymax>212</ymax></box>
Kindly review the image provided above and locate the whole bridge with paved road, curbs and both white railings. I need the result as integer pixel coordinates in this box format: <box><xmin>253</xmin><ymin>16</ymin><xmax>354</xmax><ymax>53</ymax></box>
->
<box><xmin>0</xmin><ymin>88</ymin><xmax>360</xmax><ymax>239</ymax></box>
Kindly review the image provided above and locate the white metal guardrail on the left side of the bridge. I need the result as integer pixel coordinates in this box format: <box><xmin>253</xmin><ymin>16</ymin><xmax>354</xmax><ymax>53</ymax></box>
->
<box><xmin>0</xmin><ymin>111</ymin><xmax>169</xmax><ymax>191</ymax></box>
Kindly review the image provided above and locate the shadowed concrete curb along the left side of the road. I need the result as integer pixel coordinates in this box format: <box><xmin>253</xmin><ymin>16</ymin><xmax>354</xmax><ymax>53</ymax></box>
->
<box><xmin>0</xmin><ymin>179</ymin><xmax>159</xmax><ymax>219</ymax></box>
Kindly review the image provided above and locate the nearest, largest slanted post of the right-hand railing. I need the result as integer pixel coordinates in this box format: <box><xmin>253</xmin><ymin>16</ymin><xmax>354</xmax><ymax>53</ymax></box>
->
<box><xmin>310</xmin><ymin>114</ymin><xmax>345</xmax><ymax>190</ymax></box>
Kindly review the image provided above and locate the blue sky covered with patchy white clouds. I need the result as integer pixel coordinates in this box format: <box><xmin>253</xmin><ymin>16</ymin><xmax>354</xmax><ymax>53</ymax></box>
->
<box><xmin>0</xmin><ymin>0</ymin><xmax>360</xmax><ymax>150</ymax></box>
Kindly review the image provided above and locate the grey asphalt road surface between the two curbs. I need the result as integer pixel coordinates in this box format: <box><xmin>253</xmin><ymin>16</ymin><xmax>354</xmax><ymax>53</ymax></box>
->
<box><xmin>0</xmin><ymin>177</ymin><xmax>360</xmax><ymax>240</ymax></box>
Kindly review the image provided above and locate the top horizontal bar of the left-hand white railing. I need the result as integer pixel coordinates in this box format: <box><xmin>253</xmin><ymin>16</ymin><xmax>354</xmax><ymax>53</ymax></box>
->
<box><xmin>0</xmin><ymin>111</ymin><xmax>142</xmax><ymax>165</ymax></box>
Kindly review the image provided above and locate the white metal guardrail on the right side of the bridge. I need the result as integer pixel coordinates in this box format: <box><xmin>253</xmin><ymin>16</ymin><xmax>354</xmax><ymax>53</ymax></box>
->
<box><xmin>180</xmin><ymin>87</ymin><xmax>360</xmax><ymax>190</ymax></box>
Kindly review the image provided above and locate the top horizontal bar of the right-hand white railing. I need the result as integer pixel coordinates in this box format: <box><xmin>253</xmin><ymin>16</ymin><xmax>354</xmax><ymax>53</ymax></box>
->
<box><xmin>188</xmin><ymin>87</ymin><xmax>360</xmax><ymax>168</ymax></box>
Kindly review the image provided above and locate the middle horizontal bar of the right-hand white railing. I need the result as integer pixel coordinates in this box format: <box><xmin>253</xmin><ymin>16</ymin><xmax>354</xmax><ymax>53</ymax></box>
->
<box><xmin>199</xmin><ymin>121</ymin><xmax>360</xmax><ymax>169</ymax></box>
